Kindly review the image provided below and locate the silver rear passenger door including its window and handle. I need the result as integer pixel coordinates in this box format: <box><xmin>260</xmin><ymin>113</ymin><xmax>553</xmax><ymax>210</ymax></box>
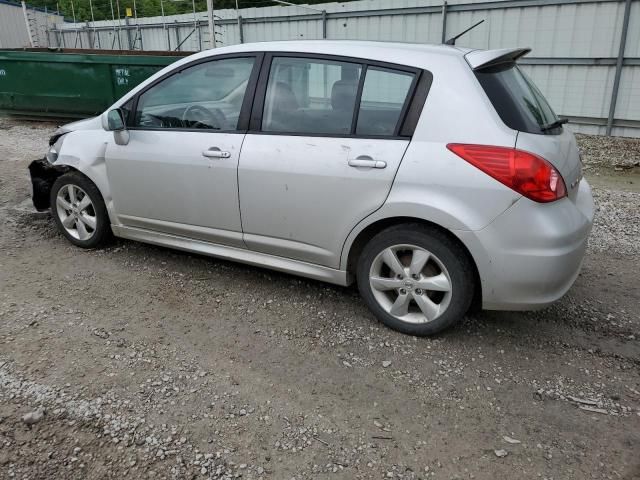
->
<box><xmin>238</xmin><ymin>54</ymin><xmax>420</xmax><ymax>268</ymax></box>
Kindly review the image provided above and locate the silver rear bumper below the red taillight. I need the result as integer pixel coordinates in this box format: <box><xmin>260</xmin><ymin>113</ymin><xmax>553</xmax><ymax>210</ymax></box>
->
<box><xmin>454</xmin><ymin>179</ymin><xmax>594</xmax><ymax>310</ymax></box>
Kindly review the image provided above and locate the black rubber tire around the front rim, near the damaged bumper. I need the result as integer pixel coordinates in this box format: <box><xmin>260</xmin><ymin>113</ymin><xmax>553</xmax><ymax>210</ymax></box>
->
<box><xmin>49</xmin><ymin>172</ymin><xmax>113</xmax><ymax>248</ymax></box>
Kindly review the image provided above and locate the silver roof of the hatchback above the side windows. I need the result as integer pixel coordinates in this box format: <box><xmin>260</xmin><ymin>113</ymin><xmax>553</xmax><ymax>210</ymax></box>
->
<box><xmin>190</xmin><ymin>40</ymin><xmax>471</xmax><ymax>67</ymax></box>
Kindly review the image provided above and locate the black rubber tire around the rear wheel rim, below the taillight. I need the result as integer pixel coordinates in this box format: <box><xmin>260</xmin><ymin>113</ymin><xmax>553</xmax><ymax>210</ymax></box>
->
<box><xmin>356</xmin><ymin>224</ymin><xmax>475</xmax><ymax>337</ymax></box>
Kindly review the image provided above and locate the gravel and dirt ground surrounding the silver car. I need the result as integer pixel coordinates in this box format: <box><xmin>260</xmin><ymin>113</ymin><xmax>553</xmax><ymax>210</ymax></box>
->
<box><xmin>0</xmin><ymin>119</ymin><xmax>640</xmax><ymax>480</ymax></box>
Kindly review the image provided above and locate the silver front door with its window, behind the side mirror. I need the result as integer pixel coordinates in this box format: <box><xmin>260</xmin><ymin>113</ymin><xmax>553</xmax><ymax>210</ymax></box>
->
<box><xmin>105</xmin><ymin>56</ymin><xmax>257</xmax><ymax>247</ymax></box>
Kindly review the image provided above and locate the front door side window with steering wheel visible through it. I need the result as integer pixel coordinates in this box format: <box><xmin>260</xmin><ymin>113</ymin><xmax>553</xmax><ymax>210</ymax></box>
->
<box><xmin>133</xmin><ymin>57</ymin><xmax>255</xmax><ymax>131</ymax></box>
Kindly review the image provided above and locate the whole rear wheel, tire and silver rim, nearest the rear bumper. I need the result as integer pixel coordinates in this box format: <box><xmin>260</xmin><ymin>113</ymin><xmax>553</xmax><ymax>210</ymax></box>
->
<box><xmin>357</xmin><ymin>224</ymin><xmax>474</xmax><ymax>336</ymax></box>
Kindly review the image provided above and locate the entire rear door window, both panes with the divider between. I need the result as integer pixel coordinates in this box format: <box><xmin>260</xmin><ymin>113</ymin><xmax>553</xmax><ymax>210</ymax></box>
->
<box><xmin>261</xmin><ymin>56</ymin><xmax>418</xmax><ymax>137</ymax></box>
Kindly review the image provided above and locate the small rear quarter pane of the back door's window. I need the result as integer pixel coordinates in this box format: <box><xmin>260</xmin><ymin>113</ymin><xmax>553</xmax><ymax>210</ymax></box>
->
<box><xmin>356</xmin><ymin>67</ymin><xmax>415</xmax><ymax>136</ymax></box>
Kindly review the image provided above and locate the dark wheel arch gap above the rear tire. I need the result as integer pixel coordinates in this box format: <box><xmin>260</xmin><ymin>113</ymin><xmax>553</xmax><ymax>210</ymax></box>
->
<box><xmin>343</xmin><ymin>216</ymin><xmax>482</xmax><ymax>311</ymax></box>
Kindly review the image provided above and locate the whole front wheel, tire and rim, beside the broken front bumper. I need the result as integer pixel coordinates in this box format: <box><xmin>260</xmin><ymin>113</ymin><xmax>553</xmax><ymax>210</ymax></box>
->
<box><xmin>50</xmin><ymin>172</ymin><xmax>111</xmax><ymax>248</ymax></box>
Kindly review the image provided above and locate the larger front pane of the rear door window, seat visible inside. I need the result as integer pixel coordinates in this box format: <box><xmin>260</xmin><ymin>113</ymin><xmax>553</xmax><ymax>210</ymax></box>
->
<box><xmin>262</xmin><ymin>57</ymin><xmax>362</xmax><ymax>135</ymax></box>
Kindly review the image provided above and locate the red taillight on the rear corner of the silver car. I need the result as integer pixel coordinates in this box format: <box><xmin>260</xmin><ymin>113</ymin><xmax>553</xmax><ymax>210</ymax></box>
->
<box><xmin>447</xmin><ymin>143</ymin><xmax>567</xmax><ymax>203</ymax></box>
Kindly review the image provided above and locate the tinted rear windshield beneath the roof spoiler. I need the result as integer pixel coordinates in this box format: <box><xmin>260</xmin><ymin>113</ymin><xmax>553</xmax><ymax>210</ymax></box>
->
<box><xmin>476</xmin><ymin>63</ymin><xmax>562</xmax><ymax>134</ymax></box>
